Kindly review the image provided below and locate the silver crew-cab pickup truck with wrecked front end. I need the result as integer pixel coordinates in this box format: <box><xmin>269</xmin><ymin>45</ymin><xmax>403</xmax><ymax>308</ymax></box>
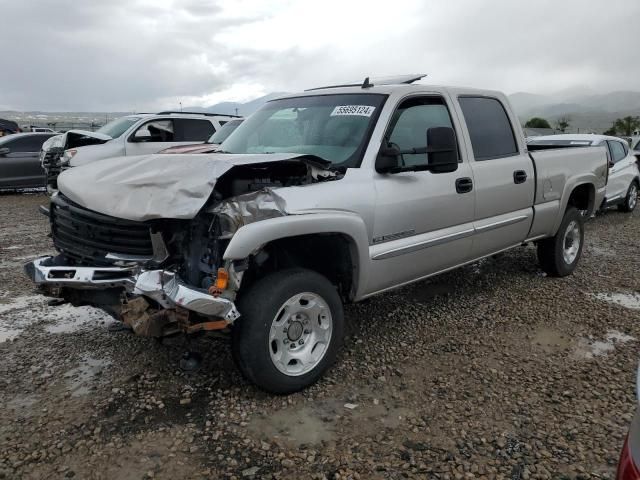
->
<box><xmin>25</xmin><ymin>76</ymin><xmax>607</xmax><ymax>393</ymax></box>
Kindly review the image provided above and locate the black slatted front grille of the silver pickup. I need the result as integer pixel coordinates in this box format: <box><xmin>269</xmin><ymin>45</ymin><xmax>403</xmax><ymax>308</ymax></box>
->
<box><xmin>50</xmin><ymin>194</ymin><xmax>153</xmax><ymax>265</ymax></box>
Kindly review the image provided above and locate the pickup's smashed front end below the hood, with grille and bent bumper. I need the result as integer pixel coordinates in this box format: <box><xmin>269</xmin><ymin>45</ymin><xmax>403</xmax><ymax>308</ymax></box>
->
<box><xmin>25</xmin><ymin>157</ymin><xmax>336</xmax><ymax>337</ymax></box>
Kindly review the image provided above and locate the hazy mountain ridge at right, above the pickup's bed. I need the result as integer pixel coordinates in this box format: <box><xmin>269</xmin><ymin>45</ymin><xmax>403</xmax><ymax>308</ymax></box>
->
<box><xmin>509</xmin><ymin>87</ymin><xmax>640</xmax><ymax>133</ymax></box>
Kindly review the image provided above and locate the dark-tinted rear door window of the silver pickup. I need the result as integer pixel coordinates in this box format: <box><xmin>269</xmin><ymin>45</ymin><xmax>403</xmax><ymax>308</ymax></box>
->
<box><xmin>459</xmin><ymin>97</ymin><xmax>518</xmax><ymax>160</ymax></box>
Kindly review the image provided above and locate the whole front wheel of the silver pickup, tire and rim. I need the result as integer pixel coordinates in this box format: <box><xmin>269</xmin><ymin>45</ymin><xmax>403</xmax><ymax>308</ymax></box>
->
<box><xmin>232</xmin><ymin>269</ymin><xmax>344</xmax><ymax>394</ymax></box>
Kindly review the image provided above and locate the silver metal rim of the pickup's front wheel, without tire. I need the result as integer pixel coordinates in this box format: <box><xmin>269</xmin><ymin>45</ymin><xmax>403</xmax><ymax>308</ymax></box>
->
<box><xmin>267</xmin><ymin>292</ymin><xmax>333</xmax><ymax>377</ymax></box>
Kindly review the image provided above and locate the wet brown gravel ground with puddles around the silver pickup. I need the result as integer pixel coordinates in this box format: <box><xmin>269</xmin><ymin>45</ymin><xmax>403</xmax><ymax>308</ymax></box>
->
<box><xmin>0</xmin><ymin>195</ymin><xmax>640</xmax><ymax>480</ymax></box>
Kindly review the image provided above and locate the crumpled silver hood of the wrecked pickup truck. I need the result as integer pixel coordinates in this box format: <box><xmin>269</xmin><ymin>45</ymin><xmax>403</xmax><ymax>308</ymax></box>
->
<box><xmin>58</xmin><ymin>153</ymin><xmax>328</xmax><ymax>221</ymax></box>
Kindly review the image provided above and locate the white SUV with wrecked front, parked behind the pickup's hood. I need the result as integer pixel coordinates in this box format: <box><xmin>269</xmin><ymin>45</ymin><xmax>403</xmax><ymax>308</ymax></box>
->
<box><xmin>40</xmin><ymin>111</ymin><xmax>237</xmax><ymax>190</ymax></box>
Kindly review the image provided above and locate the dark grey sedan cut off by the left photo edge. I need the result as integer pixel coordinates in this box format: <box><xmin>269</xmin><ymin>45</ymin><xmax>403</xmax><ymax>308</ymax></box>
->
<box><xmin>0</xmin><ymin>133</ymin><xmax>55</xmax><ymax>190</ymax></box>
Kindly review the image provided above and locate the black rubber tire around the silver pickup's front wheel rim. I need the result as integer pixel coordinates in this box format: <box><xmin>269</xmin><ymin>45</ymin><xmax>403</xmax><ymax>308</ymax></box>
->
<box><xmin>231</xmin><ymin>268</ymin><xmax>344</xmax><ymax>394</ymax></box>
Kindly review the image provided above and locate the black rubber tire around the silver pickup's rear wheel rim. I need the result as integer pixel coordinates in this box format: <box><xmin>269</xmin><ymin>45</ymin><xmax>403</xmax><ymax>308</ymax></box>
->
<box><xmin>538</xmin><ymin>207</ymin><xmax>584</xmax><ymax>277</ymax></box>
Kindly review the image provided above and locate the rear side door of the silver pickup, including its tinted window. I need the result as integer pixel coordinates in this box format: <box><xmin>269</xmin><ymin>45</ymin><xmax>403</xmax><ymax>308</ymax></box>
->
<box><xmin>458</xmin><ymin>95</ymin><xmax>535</xmax><ymax>257</ymax></box>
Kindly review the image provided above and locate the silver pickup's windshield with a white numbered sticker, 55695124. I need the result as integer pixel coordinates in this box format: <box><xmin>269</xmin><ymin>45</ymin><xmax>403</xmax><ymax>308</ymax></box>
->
<box><xmin>221</xmin><ymin>94</ymin><xmax>386</xmax><ymax>167</ymax></box>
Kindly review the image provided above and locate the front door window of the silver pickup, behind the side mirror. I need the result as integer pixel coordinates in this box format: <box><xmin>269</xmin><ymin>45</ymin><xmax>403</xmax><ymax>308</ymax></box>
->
<box><xmin>387</xmin><ymin>97</ymin><xmax>453</xmax><ymax>165</ymax></box>
